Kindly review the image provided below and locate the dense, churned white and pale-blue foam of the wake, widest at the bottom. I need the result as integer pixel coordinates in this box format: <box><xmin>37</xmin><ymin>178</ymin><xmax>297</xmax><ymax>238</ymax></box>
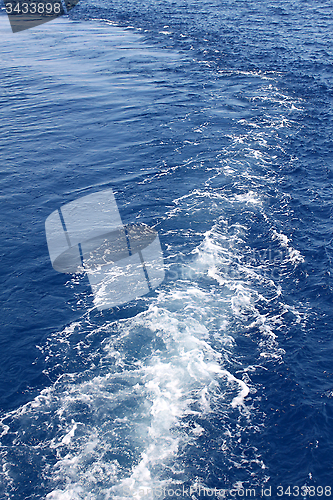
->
<box><xmin>2</xmin><ymin>205</ymin><xmax>308</xmax><ymax>500</ymax></box>
